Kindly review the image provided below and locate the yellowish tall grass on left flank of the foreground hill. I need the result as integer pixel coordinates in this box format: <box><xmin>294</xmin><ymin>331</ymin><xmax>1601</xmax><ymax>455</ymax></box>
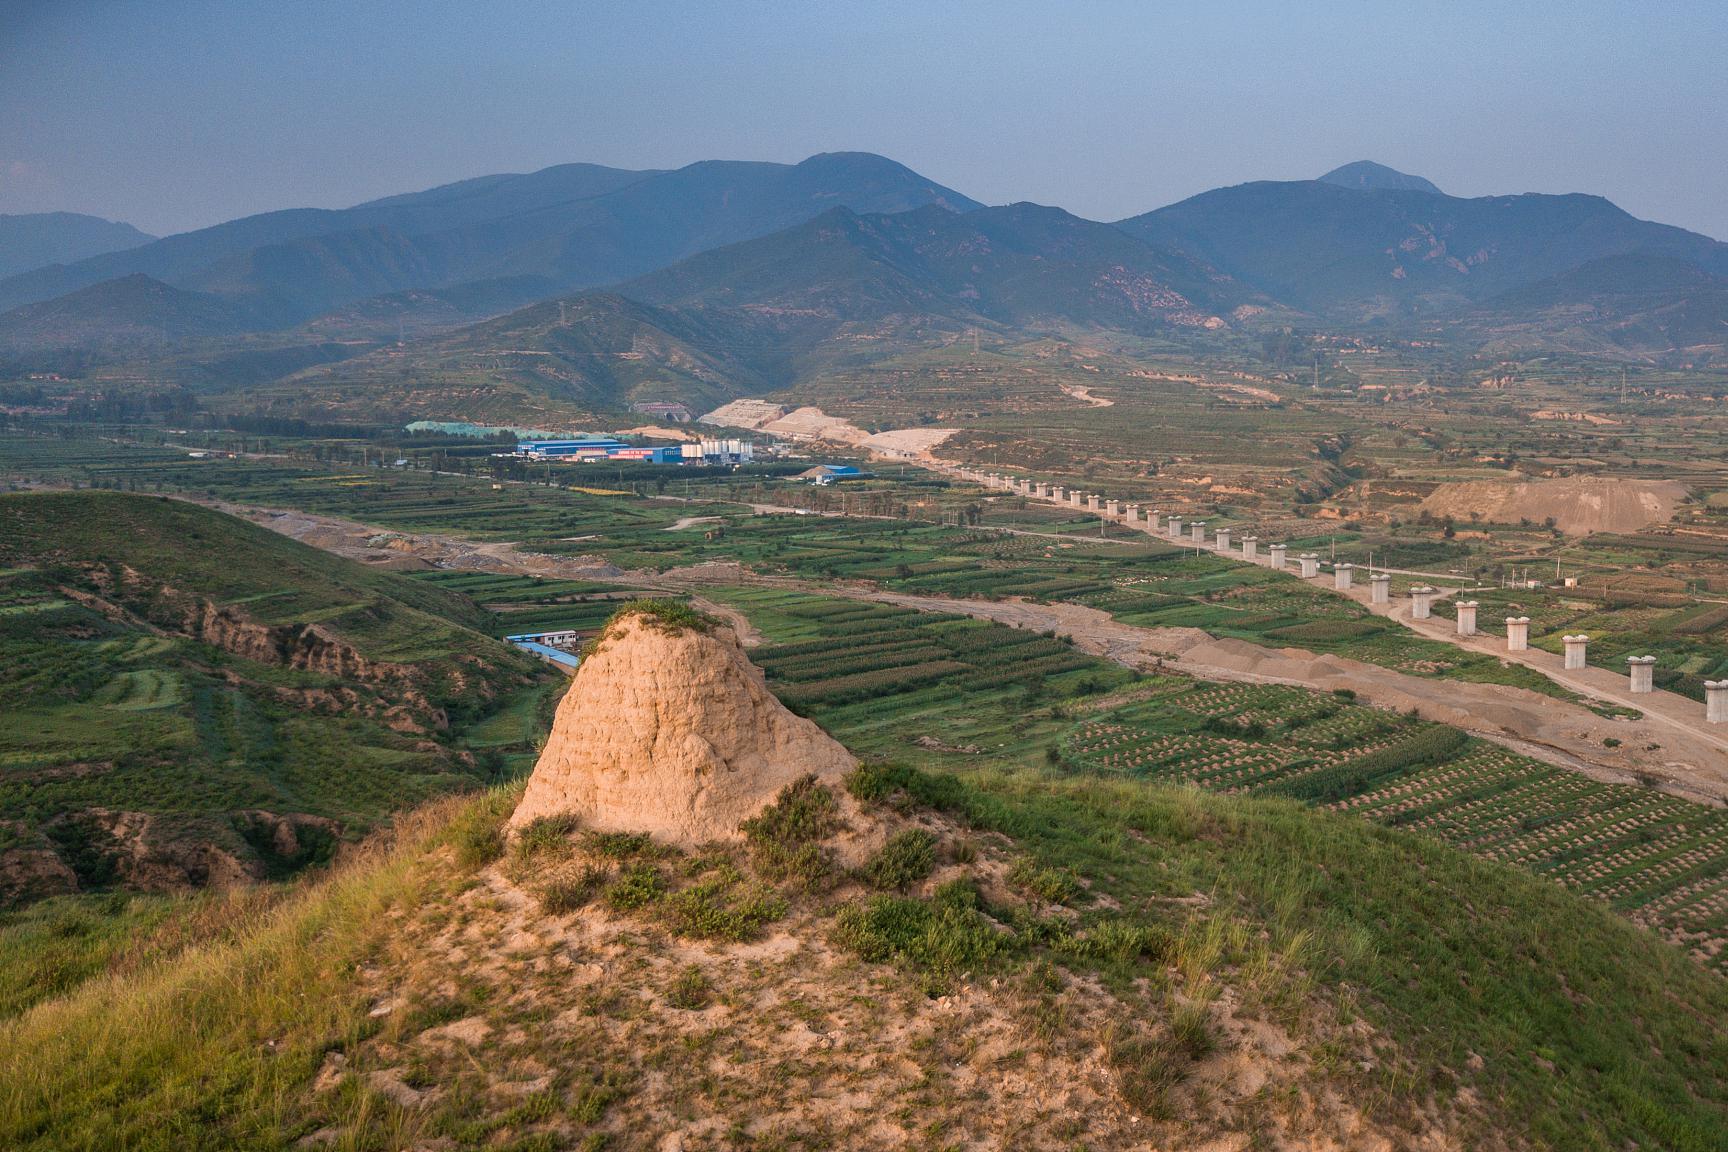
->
<box><xmin>0</xmin><ymin>789</ymin><xmax>515</xmax><ymax>1152</ymax></box>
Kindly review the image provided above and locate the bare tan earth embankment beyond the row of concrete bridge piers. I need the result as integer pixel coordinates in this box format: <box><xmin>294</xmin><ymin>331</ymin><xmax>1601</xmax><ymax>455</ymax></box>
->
<box><xmin>1420</xmin><ymin>477</ymin><xmax>1687</xmax><ymax>535</ymax></box>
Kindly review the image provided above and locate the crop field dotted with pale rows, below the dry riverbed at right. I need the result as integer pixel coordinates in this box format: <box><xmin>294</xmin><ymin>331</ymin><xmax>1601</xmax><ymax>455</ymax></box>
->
<box><xmin>1061</xmin><ymin>684</ymin><xmax>1728</xmax><ymax>971</ymax></box>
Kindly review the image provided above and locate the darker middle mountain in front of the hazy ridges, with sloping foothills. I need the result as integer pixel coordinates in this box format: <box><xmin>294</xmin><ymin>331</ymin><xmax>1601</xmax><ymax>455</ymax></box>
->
<box><xmin>279</xmin><ymin>204</ymin><xmax>1270</xmax><ymax>419</ymax></box>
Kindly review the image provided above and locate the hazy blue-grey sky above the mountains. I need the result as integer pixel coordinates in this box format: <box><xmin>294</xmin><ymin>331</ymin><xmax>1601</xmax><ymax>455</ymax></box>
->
<box><xmin>10</xmin><ymin>0</ymin><xmax>1728</xmax><ymax>238</ymax></box>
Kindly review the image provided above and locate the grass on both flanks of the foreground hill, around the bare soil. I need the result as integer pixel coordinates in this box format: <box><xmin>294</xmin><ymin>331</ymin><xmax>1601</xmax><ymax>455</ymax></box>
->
<box><xmin>0</xmin><ymin>769</ymin><xmax>1728</xmax><ymax>1150</ymax></box>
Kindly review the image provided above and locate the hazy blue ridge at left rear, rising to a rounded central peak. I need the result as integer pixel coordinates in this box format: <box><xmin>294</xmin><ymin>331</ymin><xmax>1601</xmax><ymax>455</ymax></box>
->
<box><xmin>0</xmin><ymin>154</ymin><xmax>976</xmax><ymax>328</ymax></box>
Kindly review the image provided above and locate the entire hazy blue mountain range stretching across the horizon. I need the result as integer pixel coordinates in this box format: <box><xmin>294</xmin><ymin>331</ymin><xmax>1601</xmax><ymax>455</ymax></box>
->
<box><xmin>0</xmin><ymin>152</ymin><xmax>1728</xmax><ymax>406</ymax></box>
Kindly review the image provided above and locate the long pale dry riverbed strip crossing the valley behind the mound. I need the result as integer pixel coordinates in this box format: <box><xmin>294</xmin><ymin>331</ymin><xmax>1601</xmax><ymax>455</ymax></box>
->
<box><xmin>221</xmin><ymin>504</ymin><xmax>1728</xmax><ymax>803</ymax></box>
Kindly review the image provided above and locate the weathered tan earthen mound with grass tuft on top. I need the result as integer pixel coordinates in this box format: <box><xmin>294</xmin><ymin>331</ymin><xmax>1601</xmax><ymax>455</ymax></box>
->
<box><xmin>510</xmin><ymin>610</ymin><xmax>857</xmax><ymax>846</ymax></box>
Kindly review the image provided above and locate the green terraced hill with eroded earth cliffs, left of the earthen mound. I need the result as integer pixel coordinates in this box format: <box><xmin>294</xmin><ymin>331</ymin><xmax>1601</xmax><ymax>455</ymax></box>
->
<box><xmin>0</xmin><ymin>492</ymin><xmax>544</xmax><ymax>902</ymax></box>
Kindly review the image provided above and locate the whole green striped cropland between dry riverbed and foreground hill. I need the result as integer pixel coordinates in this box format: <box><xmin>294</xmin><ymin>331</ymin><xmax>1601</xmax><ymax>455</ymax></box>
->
<box><xmin>714</xmin><ymin>589</ymin><xmax>1728</xmax><ymax>969</ymax></box>
